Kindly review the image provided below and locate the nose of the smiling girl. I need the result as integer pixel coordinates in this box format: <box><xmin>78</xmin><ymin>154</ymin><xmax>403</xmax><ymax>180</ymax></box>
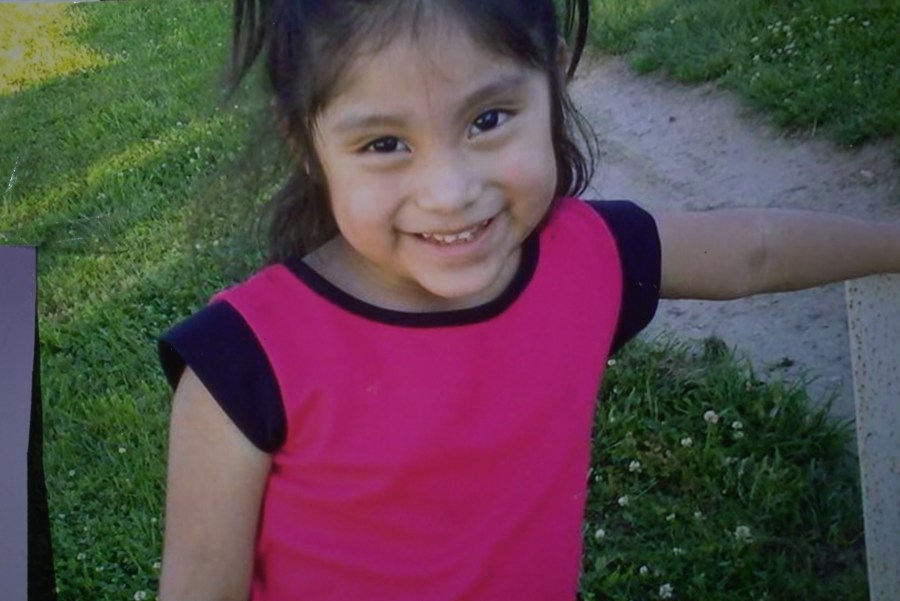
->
<box><xmin>417</xmin><ymin>153</ymin><xmax>479</xmax><ymax>213</ymax></box>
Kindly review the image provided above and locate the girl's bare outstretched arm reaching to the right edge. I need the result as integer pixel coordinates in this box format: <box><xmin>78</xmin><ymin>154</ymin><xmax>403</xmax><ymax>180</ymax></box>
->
<box><xmin>654</xmin><ymin>209</ymin><xmax>900</xmax><ymax>300</ymax></box>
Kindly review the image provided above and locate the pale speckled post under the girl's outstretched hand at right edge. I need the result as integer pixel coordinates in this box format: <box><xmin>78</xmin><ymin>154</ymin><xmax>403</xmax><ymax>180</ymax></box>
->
<box><xmin>847</xmin><ymin>276</ymin><xmax>900</xmax><ymax>601</ymax></box>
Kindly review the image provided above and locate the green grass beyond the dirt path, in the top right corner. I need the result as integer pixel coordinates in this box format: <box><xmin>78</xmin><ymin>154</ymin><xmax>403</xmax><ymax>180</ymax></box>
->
<box><xmin>591</xmin><ymin>0</ymin><xmax>900</xmax><ymax>145</ymax></box>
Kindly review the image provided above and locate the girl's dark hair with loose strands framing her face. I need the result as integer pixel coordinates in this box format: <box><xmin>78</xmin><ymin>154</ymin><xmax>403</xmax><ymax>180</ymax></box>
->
<box><xmin>231</xmin><ymin>0</ymin><xmax>594</xmax><ymax>261</ymax></box>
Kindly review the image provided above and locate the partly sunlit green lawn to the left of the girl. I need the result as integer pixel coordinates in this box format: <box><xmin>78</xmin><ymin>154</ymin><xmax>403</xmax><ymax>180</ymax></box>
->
<box><xmin>0</xmin><ymin>1</ymin><xmax>257</xmax><ymax>599</ymax></box>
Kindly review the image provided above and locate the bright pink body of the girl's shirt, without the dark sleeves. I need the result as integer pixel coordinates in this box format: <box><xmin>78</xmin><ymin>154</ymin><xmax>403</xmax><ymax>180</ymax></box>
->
<box><xmin>158</xmin><ymin>200</ymin><xmax>656</xmax><ymax>601</ymax></box>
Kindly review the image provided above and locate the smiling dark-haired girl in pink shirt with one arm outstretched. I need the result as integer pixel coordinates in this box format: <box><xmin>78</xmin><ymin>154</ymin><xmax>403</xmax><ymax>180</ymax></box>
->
<box><xmin>160</xmin><ymin>0</ymin><xmax>900</xmax><ymax>601</ymax></box>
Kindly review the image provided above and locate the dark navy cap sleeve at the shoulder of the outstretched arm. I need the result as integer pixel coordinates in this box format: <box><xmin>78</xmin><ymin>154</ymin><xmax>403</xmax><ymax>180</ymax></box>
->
<box><xmin>588</xmin><ymin>200</ymin><xmax>662</xmax><ymax>354</ymax></box>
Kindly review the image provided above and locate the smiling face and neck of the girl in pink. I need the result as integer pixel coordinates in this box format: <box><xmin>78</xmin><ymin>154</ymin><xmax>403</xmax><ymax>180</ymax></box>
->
<box><xmin>307</xmin><ymin>21</ymin><xmax>556</xmax><ymax>311</ymax></box>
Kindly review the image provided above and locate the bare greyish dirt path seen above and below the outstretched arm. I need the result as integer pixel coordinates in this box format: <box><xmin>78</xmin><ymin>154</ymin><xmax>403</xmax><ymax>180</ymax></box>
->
<box><xmin>572</xmin><ymin>57</ymin><xmax>900</xmax><ymax>417</ymax></box>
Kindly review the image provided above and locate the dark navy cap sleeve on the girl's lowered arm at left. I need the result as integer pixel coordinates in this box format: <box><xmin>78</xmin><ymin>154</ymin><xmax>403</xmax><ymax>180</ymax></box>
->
<box><xmin>159</xmin><ymin>301</ymin><xmax>287</xmax><ymax>453</ymax></box>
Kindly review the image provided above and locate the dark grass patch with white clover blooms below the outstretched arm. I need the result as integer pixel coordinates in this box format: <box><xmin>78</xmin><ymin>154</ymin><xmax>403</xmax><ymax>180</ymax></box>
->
<box><xmin>582</xmin><ymin>341</ymin><xmax>867</xmax><ymax>601</ymax></box>
